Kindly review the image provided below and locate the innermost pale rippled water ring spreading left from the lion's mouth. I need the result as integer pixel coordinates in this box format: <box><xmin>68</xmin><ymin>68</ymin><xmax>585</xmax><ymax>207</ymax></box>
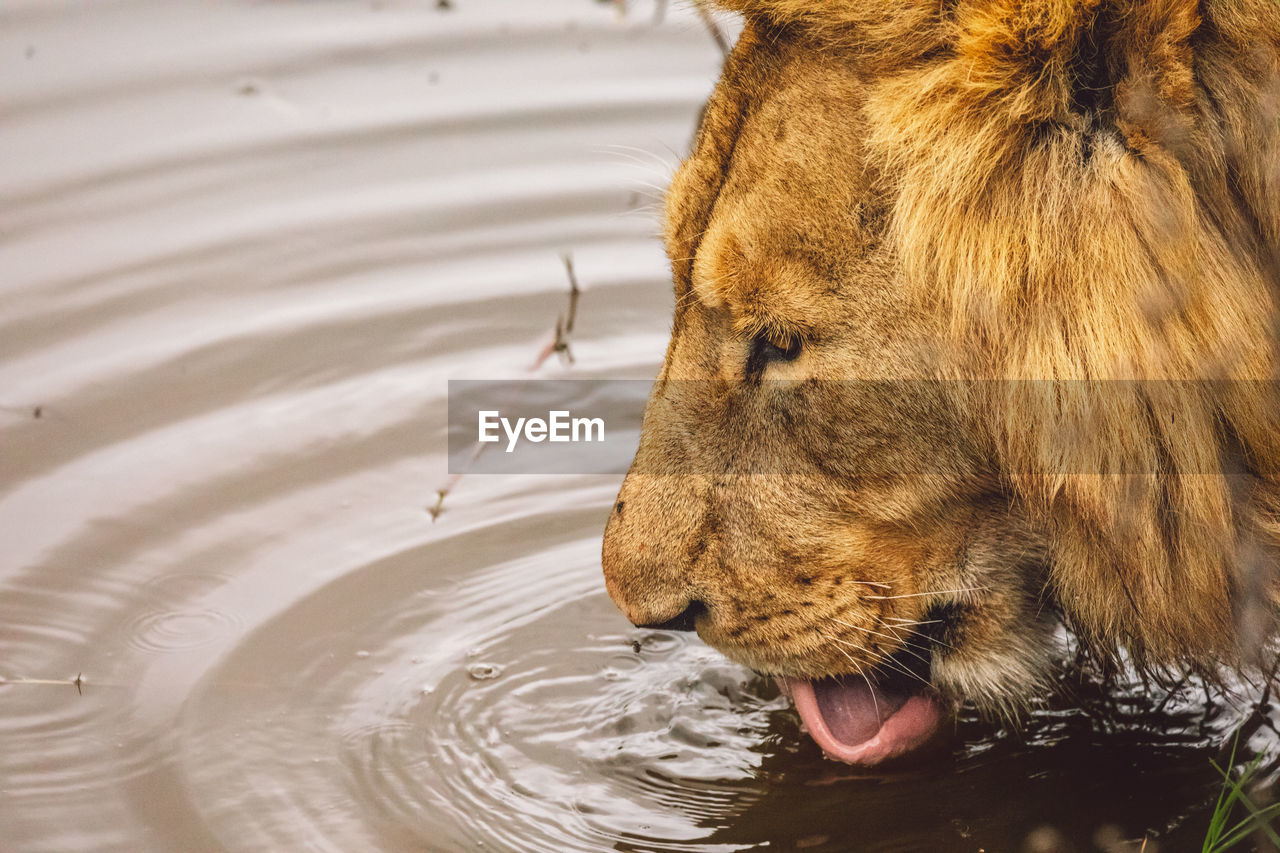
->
<box><xmin>182</xmin><ymin>503</ymin><xmax>786</xmax><ymax>850</ymax></box>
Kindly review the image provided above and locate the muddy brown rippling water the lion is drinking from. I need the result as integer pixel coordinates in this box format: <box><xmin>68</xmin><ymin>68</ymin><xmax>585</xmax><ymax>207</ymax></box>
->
<box><xmin>0</xmin><ymin>0</ymin><xmax>1277</xmax><ymax>853</ymax></box>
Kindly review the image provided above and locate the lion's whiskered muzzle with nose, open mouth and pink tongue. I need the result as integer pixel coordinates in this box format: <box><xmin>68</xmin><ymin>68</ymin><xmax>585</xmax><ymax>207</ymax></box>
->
<box><xmin>604</xmin><ymin>458</ymin><xmax>1056</xmax><ymax>765</ymax></box>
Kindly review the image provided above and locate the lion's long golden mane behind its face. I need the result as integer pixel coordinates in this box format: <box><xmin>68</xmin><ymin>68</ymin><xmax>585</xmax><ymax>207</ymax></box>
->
<box><xmin>718</xmin><ymin>0</ymin><xmax>1280</xmax><ymax>669</ymax></box>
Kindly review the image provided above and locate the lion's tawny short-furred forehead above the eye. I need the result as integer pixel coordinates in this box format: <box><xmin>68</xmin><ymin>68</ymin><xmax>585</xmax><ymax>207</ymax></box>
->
<box><xmin>667</xmin><ymin>34</ymin><xmax>887</xmax><ymax>337</ymax></box>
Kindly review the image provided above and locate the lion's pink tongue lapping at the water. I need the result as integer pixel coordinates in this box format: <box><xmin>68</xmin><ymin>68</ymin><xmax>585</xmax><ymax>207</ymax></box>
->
<box><xmin>778</xmin><ymin>676</ymin><xmax>946</xmax><ymax>767</ymax></box>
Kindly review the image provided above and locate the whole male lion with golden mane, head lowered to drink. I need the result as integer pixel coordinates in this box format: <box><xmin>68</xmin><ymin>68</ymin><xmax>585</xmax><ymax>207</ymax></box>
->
<box><xmin>603</xmin><ymin>0</ymin><xmax>1280</xmax><ymax>766</ymax></box>
